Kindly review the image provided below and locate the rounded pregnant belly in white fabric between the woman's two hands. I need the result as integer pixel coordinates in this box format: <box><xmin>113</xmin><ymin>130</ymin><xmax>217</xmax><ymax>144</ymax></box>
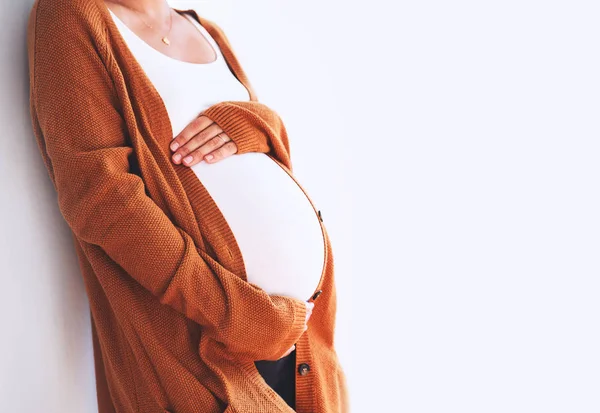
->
<box><xmin>192</xmin><ymin>152</ymin><xmax>325</xmax><ymax>300</ymax></box>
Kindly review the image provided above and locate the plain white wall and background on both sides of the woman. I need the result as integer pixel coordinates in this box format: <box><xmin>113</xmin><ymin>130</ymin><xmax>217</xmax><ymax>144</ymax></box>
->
<box><xmin>0</xmin><ymin>0</ymin><xmax>600</xmax><ymax>413</ymax></box>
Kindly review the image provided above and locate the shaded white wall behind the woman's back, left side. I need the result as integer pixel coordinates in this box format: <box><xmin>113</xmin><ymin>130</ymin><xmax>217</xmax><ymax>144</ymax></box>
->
<box><xmin>0</xmin><ymin>0</ymin><xmax>96</xmax><ymax>413</ymax></box>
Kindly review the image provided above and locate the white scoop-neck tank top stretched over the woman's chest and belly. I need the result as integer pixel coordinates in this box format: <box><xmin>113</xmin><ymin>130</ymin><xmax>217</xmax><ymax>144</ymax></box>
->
<box><xmin>109</xmin><ymin>9</ymin><xmax>325</xmax><ymax>300</ymax></box>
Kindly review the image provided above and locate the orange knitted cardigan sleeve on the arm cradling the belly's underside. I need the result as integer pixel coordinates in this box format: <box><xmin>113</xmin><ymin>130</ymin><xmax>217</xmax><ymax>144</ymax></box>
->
<box><xmin>28</xmin><ymin>0</ymin><xmax>306</xmax><ymax>360</ymax></box>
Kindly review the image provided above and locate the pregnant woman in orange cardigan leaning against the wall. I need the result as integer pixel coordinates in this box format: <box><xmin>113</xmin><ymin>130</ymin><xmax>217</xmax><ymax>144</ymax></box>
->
<box><xmin>27</xmin><ymin>0</ymin><xmax>348</xmax><ymax>413</ymax></box>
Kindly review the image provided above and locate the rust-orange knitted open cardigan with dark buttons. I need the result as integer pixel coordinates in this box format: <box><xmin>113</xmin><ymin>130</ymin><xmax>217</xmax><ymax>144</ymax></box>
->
<box><xmin>27</xmin><ymin>0</ymin><xmax>349</xmax><ymax>413</ymax></box>
